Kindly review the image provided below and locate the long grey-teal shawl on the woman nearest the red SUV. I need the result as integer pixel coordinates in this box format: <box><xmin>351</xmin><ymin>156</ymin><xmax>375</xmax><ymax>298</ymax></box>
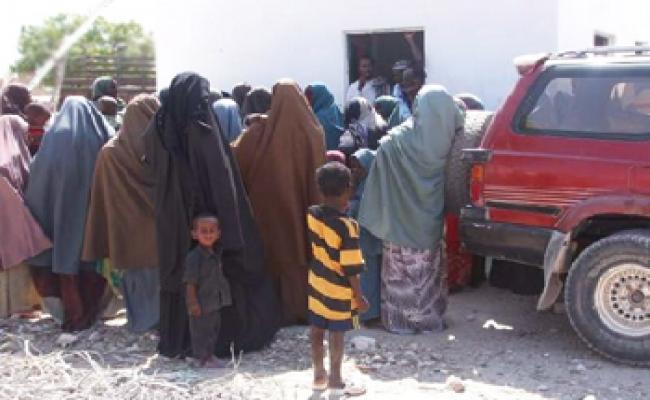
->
<box><xmin>359</xmin><ymin>85</ymin><xmax>464</xmax><ymax>249</ymax></box>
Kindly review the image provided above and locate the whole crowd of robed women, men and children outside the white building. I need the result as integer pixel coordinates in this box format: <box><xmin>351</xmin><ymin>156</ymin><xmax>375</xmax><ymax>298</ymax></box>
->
<box><xmin>0</xmin><ymin>59</ymin><xmax>480</xmax><ymax>385</ymax></box>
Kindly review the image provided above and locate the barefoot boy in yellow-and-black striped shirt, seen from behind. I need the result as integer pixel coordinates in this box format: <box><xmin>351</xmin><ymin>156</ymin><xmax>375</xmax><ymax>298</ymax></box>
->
<box><xmin>307</xmin><ymin>162</ymin><xmax>368</xmax><ymax>394</ymax></box>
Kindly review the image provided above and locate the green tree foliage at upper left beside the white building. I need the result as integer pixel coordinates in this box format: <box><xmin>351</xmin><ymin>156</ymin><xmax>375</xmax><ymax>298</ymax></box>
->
<box><xmin>12</xmin><ymin>14</ymin><xmax>154</xmax><ymax>84</ymax></box>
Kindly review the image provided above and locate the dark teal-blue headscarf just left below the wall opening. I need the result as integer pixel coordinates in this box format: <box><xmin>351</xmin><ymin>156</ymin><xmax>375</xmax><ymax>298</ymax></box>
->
<box><xmin>305</xmin><ymin>82</ymin><xmax>344</xmax><ymax>150</ymax></box>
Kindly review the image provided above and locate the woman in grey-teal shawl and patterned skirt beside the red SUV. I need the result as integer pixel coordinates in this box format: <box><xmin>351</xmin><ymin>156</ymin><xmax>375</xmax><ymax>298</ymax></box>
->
<box><xmin>359</xmin><ymin>85</ymin><xmax>463</xmax><ymax>333</ymax></box>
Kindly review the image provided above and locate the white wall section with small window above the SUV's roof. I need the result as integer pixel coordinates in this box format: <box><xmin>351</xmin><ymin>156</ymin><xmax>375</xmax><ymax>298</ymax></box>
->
<box><xmin>558</xmin><ymin>0</ymin><xmax>650</xmax><ymax>51</ymax></box>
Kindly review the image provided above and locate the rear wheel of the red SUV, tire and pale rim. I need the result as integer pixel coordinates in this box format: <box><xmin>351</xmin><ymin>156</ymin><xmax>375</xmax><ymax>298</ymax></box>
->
<box><xmin>565</xmin><ymin>230</ymin><xmax>650</xmax><ymax>366</ymax></box>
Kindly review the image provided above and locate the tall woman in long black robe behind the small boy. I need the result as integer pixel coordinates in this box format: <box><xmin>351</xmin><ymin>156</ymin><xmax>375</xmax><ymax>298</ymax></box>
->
<box><xmin>143</xmin><ymin>73</ymin><xmax>279</xmax><ymax>357</ymax></box>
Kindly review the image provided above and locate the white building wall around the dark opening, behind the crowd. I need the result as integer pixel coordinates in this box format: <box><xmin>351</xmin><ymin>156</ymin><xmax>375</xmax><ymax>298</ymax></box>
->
<box><xmin>155</xmin><ymin>0</ymin><xmax>562</xmax><ymax>108</ymax></box>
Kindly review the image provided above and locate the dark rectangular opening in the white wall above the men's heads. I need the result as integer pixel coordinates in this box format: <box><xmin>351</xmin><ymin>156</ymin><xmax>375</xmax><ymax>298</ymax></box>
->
<box><xmin>346</xmin><ymin>30</ymin><xmax>425</xmax><ymax>87</ymax></box>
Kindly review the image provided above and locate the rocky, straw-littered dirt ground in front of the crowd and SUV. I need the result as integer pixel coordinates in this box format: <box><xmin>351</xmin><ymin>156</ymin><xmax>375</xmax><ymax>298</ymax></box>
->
<box><xmin>0</xmin><ymin>286</ymin><xmax>650</xmax><ymax>400</ymax></box>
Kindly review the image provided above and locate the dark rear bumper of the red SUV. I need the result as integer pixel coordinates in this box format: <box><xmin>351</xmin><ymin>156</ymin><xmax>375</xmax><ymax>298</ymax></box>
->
<box><xmin>460</xmin><ymin>206</ymin><xmax>553</xmax><ymax>267</ymax></box>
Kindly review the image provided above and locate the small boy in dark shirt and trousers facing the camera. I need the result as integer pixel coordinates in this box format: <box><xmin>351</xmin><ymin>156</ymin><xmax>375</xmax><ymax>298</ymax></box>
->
<box><xmin>183</xmin><ymin>214</ymin><xmax>232</xmax><ymax>368</ymax></box>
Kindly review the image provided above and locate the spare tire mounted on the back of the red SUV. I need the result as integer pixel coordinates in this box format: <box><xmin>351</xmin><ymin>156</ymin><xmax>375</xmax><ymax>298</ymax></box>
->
<box><xmin>445</xmin><ymin>111</ymin><xmax>494</xmax><ymax>214</ymax></box>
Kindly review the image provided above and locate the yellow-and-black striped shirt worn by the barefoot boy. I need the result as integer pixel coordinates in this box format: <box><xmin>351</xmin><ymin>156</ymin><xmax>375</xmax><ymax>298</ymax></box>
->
<box><xmin>307</xmin><ymin>206</ymin><xmax>364</xmax><ymax>329</ymax></box>
